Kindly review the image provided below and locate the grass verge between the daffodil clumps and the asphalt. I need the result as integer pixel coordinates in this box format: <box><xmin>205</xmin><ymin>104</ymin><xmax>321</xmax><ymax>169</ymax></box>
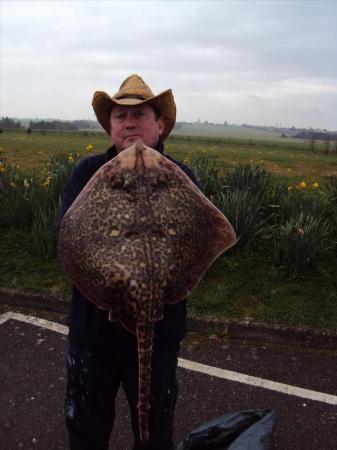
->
<box><xmin>0</xmin><ymin>228</ymin><xmax>337</xmax><ymax>331</ymax></box>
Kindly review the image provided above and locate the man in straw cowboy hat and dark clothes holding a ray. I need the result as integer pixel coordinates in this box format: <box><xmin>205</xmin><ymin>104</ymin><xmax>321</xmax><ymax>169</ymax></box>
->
<box><xmin>58</xmin><ymin>75</ymin><xmax>200</xmax><ymax>450</ymax></box>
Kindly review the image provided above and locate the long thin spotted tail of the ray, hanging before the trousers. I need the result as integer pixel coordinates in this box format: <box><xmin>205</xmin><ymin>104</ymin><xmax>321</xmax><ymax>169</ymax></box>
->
<box><xmin>137</xmin><ymin>324</ymin><xmax>154</xmax><ymax>441</ymax></box>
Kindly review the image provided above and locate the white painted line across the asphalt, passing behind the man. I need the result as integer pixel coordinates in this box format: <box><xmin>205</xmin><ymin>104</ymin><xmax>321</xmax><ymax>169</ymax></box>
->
<box><xmin>0</xmin><ymin>312</ymin><xmax>337</xmax><ymax>405</ymax></box>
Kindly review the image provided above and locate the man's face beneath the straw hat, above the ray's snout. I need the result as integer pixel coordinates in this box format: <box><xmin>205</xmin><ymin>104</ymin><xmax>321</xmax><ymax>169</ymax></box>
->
<box><xmin>110</xmin><ymin>104</ymin><xmax>164</xmax><ymax>153</ymax></box>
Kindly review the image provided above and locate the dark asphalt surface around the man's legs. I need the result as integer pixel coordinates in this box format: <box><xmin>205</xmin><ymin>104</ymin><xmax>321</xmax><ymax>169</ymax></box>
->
<box><xmin>0</xmin><ymin>307</ymin><xmax>337</xmax><ymax>450</ymax></box>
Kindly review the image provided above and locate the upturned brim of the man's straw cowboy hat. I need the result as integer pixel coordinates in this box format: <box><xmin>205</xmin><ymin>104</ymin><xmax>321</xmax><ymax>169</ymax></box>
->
<box><xmin>92</xmin><ymin>89</ymin><xmax>176</xmax><ymax>140</ymax></box>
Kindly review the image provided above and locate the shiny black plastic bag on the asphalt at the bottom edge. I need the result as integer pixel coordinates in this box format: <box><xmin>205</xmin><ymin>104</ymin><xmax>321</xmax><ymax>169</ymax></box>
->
<box><xmin>176</xmin><ymin>409</ymin><xmax>276</xmax><ymax>450</ymax></box>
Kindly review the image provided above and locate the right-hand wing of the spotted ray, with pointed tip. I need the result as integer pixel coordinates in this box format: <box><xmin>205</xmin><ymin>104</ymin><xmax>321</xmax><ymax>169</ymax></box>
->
<box><xmin>146</xmin><ymin>155</ymin><xmax>236</xmax><ymax>304</ymax></box>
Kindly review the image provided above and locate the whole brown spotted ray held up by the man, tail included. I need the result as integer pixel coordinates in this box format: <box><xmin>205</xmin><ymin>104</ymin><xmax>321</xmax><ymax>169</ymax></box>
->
<box><xmin>59</xmin><ymin>143</ymin><xmax>236</xmax><ymax>440</ymax></box>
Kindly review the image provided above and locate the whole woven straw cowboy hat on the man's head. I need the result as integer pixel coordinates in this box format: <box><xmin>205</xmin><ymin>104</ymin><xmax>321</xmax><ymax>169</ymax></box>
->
<box><xmin>92</xmin><ymin>74</ymin><xmax>176</xmax><ymax>140</ymax></box>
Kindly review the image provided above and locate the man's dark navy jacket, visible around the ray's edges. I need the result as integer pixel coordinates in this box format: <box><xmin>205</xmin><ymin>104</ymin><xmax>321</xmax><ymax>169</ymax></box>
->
<box><xmin>57</xmin><ymin>143</ymin><xmax>201</xmax><ymax>345</ymax></box>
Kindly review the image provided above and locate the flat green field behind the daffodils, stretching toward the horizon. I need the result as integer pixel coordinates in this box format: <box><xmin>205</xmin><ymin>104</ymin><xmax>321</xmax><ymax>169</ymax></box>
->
<box><xmin>0</xmin><ymin>129</ymin><xmax>337</xmax><ymax>184</ymax></box>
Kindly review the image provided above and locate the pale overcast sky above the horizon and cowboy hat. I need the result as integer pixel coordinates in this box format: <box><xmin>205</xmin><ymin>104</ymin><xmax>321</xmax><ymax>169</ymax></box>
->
<box><xmin>0</xmin><ymin>0</ymin><xmax>337</xmax><ymax>130</ymax></box>
